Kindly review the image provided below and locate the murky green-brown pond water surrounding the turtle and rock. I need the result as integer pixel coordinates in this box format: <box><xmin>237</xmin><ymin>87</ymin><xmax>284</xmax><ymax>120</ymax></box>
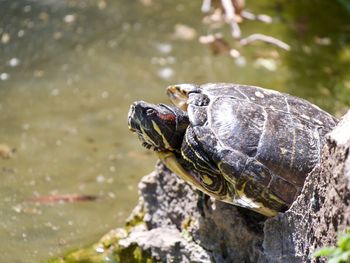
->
<box><xmin>0</xmin><ymin>0</ymin><xmax>350</xmax><ymax>262</ymax></box>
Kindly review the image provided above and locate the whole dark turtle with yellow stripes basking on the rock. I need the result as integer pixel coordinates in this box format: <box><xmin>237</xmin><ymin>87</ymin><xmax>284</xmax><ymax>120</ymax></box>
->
<box><xmin>128</xmin><ymin>83</ymin><xmax>338</xmax><ymax>217</ymax></box>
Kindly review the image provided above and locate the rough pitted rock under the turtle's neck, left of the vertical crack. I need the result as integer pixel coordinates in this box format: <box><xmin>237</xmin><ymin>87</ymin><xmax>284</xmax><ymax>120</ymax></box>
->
<box><xmin>119</xmin><ymin>163</ymin><xmax>265</xmax><ymax>262</ymax></box>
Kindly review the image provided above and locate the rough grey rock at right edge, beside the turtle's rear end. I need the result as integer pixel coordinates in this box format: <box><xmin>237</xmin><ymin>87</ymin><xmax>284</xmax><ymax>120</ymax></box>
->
<box><xmin>260</xmin><ymin>111</ymin><xmax>350</xmax><ymax>262</ymax></box>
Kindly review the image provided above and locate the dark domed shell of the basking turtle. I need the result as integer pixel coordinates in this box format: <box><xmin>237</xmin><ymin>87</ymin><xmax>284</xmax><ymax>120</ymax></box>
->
<box><xmin>182</xmin><ymin>83</ymin><xmax>337</xmax><ymax>214</ymax></box>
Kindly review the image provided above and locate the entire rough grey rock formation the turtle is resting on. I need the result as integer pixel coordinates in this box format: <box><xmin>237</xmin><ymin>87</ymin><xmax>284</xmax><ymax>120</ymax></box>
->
<box><xmin>118</xmin><ymin>112</ymin><xmax>350</xmax><ymax>263</ymax></box>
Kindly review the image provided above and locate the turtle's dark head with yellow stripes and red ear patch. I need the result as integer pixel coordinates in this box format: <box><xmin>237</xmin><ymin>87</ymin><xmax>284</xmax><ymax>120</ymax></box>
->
<box><xmin>128</xmin><ymin>101</ymin><xmax>189</xmax><ymax>151</ymax></box>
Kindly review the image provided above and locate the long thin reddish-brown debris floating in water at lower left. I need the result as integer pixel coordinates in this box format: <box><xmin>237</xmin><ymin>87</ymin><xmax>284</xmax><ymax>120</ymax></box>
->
<box><xmin>29</xmin><ymin>194</ymin><xmax>99</xmax><ymax>204</ymax></box>
